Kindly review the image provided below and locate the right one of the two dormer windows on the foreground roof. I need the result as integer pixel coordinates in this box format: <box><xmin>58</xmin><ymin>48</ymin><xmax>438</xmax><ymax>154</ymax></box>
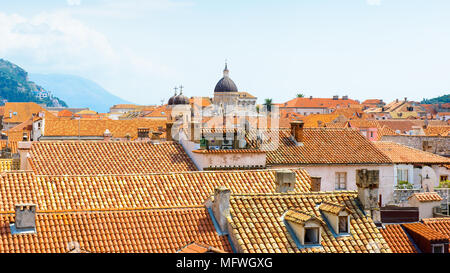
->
<box><xmin>319</xmin><ymin>202</ymin><xmax>351</xmax><ymax>236</ymax></box>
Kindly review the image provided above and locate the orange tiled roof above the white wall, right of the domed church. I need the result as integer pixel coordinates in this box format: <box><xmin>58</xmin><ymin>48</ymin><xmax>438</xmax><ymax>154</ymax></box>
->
<box><xmin>250</xmin><ymin>128</ymin><xmax>392</xmax><ymax>165</ymax></box>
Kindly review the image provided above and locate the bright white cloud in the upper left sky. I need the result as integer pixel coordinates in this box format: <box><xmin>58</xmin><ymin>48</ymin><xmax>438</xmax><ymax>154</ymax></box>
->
<box><xmin>0</xmin><ymin>12</ymin><xmax>115</xmax><ymax>69</ymax></box>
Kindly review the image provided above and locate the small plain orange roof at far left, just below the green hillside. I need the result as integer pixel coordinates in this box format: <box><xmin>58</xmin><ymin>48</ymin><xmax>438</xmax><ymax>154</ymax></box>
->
<box><xmin>3</xmin><ymin>102</ymin><xmax>57</xmax><ymax>123</ymax></box>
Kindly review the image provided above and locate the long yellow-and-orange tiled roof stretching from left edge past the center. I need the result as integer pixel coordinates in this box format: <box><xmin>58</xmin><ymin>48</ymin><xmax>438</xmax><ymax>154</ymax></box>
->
<box><xmin>0</xmin><ymin>169</ymin><xmax>311</xmax><ymax>211</ymax></box>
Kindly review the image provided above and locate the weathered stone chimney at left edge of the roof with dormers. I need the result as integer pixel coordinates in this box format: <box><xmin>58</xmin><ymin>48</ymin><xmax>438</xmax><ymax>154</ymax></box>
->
<box><xmin>212</xmin><ymin>187</ymin><xmax>231</xmax><ymax>232</ymax></box>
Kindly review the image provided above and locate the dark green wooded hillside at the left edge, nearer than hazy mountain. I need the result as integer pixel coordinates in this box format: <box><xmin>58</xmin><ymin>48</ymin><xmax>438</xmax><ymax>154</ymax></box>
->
<box><xmin>0</xmin><ymin>59</ymin><xmax>66</xmax><ymax>106</ymax></box>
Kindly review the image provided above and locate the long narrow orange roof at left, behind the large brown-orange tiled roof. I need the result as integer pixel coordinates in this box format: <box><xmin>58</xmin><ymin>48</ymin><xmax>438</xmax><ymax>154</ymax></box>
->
<box><xmin>43</xmin><ymin>119</ymin><xmax>166</xmax><ymax>138</ymax></box>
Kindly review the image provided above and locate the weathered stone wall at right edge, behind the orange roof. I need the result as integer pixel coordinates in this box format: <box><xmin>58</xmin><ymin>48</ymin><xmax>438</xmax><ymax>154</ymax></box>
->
<box><xmin>381</xmin><ymin>136</ymin><xmax>450</xmax><ymax>157</ymax></box>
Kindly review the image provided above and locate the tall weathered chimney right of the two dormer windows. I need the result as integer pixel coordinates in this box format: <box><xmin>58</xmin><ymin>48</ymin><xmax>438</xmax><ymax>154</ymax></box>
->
<box><xmin>356</xmin><ymin>169</ymin><xmax>380</xmax><ymax>222</ymax></box>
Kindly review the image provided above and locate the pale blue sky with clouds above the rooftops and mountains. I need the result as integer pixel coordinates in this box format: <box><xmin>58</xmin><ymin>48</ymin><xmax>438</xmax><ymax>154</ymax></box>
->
<box><xmin>0</xmin><ymin>0</ymin><xmax>450</xmax><ymax>104</ymax></box>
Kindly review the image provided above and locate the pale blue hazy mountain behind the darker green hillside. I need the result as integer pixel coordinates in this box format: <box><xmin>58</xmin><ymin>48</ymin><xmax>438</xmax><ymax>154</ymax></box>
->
<box><xmin>30</xmin><ymin>74</ymin><xmax>130</xmax><ymax>113</ymax></box>
